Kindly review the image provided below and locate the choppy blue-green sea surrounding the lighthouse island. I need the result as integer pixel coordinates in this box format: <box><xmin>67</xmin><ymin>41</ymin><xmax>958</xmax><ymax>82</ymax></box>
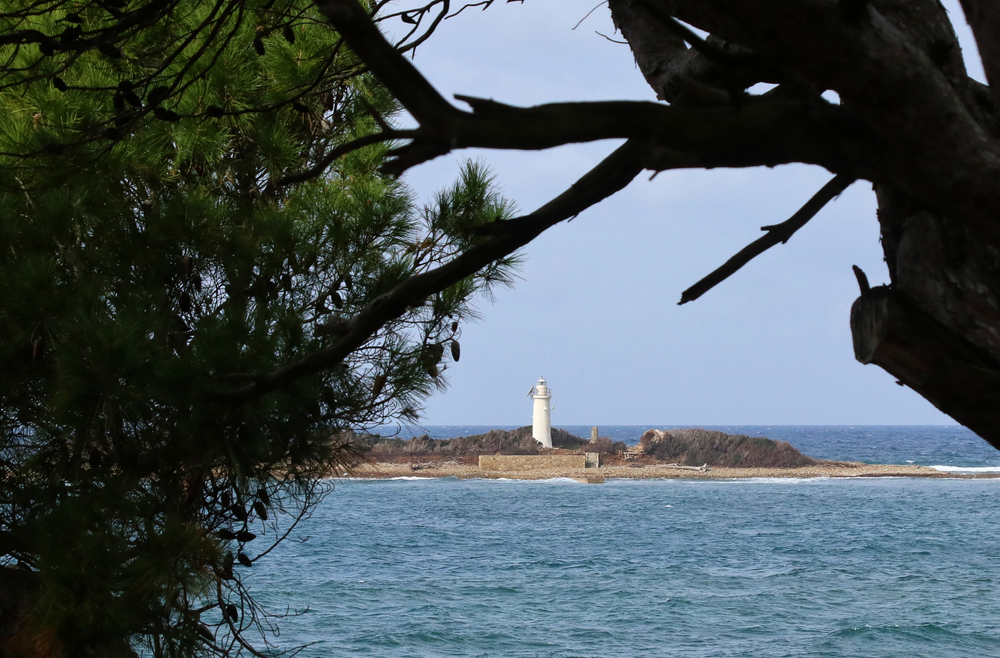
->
<box><xmin>246</xmin><ymin>425</ymin><xmax>1000</xmax><ymax>658</ymax></box>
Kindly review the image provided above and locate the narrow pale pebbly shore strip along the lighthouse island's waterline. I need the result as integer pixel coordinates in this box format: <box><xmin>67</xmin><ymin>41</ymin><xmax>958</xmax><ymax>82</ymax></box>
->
<box><xmin>337</xmin><ymin>461</ymin><xmax>1000</xmax><ymax>480</ymax></box>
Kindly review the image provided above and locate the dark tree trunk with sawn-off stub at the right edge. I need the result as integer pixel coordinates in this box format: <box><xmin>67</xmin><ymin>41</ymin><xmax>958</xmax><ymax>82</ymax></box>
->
<box><xmin>851</xmin><ymin>185</ymin><xmax>1000</xmax><ymax>448</ymax></box>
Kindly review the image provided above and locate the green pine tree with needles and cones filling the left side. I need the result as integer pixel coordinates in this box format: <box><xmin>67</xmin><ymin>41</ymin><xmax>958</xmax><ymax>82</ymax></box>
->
<box><xmin>0</xmin><ymin>0</ymin><xmax>514</xmax><ymax>656</ymax></box>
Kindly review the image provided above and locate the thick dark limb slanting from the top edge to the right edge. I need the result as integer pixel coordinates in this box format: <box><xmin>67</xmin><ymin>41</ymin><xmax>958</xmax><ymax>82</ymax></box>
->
<box><xmin>656</xmin><ymin>0</ymin><xmax>1000</xmax><ymax>245</ymax></box>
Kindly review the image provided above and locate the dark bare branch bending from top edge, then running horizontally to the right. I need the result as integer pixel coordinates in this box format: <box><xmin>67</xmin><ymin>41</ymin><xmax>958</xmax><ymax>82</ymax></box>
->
<box><xmin>320</xmin><ymin>0</ymin><xmax>867</xmax><ymax>174</ymax></box>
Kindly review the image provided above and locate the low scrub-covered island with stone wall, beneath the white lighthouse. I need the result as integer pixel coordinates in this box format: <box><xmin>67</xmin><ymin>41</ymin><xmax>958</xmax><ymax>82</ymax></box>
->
<box><xmin>338</xmin><ymin>426</ymin><xmax>1000</xmax><ymax>483</ymax></box>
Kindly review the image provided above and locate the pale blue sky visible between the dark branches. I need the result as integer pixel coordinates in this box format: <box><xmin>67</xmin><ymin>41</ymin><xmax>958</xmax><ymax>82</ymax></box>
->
<box><xmin>382</xmin><ymin>0</ymin><xmax>983</xmax><ymax>427</ymax></box>
